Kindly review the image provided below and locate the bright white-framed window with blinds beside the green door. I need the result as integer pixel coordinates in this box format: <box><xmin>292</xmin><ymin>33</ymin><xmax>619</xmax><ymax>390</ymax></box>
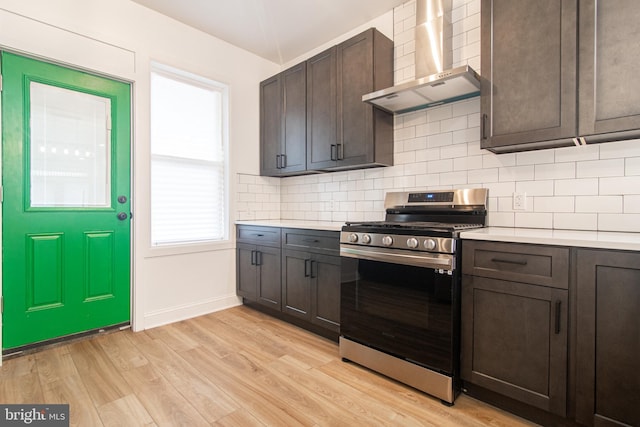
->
<box><xmin>151</xmin><ymin>65</ymin><xmax>228</xmax><ymax>246</ymax></box>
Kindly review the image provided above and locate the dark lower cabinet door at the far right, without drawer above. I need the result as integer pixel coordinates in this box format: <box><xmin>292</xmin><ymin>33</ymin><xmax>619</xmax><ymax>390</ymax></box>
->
<box><xmin>576</xmin><ymin>249</ymin><xmax>640</xmax><ymax>426</ymax></box>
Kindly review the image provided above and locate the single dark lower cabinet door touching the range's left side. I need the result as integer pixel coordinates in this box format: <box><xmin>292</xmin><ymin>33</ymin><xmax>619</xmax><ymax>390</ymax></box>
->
<box><xmin>311</xmin><ymin>254</ymin><xmax>340</xmax><ymax>332</ymax></box>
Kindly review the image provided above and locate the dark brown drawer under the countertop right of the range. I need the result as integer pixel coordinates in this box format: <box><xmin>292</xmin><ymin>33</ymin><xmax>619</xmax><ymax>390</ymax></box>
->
<box><xmin>462</xmin><ymin>240</ymin><xmax>569</xmax><ymax>289</ymax></box>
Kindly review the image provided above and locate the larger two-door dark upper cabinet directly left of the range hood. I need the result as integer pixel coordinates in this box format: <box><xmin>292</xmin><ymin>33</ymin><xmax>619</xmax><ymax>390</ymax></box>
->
<box><xmin>307</xmin><ymin>28</ymin><xmax>393</xmax><ymax>170</ymax></box>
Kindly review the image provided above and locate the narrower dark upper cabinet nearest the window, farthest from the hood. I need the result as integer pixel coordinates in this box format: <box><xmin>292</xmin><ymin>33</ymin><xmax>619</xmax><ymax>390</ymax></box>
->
<box><xmin>260</xmin><ymin>62</ymin><xmax>307</xmax><ymax>176</ymax></box>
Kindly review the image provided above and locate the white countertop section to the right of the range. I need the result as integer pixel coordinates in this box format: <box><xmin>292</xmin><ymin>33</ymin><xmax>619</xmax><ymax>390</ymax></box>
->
<box><xmin>460</xmin><ymin>227</ymin><xmax>640</xmax><ymax>251</ymax></box>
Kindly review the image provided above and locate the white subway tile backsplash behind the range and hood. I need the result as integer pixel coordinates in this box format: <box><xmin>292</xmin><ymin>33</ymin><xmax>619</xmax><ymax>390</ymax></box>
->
<box><xmin>237</xmin><ymin>0</ymin><xmax>640</xmax><ymax>232</ymax></box>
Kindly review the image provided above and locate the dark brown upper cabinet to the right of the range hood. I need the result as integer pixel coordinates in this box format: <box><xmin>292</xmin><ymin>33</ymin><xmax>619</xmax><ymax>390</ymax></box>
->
<box><xmin>481</xmin><ymin>0</ymin><xmax>640</xmax><ymax>153</ymax></box>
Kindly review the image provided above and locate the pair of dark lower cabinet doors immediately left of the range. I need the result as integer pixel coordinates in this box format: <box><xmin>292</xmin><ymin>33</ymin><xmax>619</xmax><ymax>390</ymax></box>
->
<box><xmin>282</xmin><ymin>250</ymin><xmax>340</xmax><ymax>332</ymax></box>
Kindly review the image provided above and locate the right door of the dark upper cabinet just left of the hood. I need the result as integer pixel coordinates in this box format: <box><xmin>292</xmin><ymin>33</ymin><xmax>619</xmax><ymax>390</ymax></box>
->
<box><xmin>337</xmin><ymin>30</ymin><xmax>374</xmax><ymax>166</ymax></box>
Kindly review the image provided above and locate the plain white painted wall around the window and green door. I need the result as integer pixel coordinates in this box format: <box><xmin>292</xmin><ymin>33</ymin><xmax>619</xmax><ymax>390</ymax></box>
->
<box><xmin>0</xmin><ymin>0</ymin><xmax>280</xmax><ymax>344</ymax></box>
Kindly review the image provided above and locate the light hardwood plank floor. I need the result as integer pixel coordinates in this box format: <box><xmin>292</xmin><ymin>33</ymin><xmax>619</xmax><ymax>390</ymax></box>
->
<box><xmin>0</xmin><ymin>307</ymin><xmax>534</xmax><ymax>427</ymax></box>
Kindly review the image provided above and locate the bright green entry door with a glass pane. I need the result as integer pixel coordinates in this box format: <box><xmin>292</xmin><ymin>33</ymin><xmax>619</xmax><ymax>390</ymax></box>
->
<box><xmin>0</xmin><ymin>52</ymin><xmax>131</xmax><ymax>349</ymax></box>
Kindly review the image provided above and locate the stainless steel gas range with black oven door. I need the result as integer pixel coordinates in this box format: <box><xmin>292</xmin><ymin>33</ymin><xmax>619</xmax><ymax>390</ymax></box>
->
<box><xmin>340</xmin><ymin>189</ymin><xmax>488</xmax><ymax>404</ymax></box>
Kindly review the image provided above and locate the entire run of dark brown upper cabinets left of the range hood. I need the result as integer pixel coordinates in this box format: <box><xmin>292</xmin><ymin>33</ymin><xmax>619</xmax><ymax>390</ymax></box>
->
<box><xmin>260</xmin><ymin>28</ymin><xmax>393</xmax><ymax>176</ymax></box>
